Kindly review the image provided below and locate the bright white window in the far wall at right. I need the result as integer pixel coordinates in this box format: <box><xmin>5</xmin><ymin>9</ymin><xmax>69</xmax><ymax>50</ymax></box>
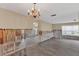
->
<box><xmin>62</xmin><ymin>25</ymin><xmax>79</xmax><ymax>35</ymax></box>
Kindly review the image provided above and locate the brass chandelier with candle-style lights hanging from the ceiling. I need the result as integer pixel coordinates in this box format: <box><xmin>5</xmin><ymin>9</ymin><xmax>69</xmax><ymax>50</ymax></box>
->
<box><xmin>28</xmin><ymin>3</ymin><xmax>40</xmax><ymax>18</ymax></box>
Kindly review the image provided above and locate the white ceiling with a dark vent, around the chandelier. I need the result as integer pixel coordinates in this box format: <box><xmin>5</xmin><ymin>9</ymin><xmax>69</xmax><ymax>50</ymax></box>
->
<box><xmin>0</xmin><ymin>3</ymin><xmax>79</xmax><ymax>24</ymax></box>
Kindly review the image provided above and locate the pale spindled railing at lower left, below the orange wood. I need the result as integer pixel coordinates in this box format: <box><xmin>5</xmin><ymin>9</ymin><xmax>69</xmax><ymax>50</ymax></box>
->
<box><xmin>0</xmin><ymin>40</ymin><xmax>21</xmax><ymax>55</ymax></box>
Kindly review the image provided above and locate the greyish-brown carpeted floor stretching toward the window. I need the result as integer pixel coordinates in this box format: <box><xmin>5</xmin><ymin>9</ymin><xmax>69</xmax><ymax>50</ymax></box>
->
<box><xmin>27</xmin><ymin>39</ymin><xmax>79</xmax><ymax>56</ymax></box>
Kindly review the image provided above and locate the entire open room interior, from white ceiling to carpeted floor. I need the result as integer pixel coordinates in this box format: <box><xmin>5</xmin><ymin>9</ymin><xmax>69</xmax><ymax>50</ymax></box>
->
<box><xmin>0</xmin><ymin>3</ymin><xmax>79</xmax><ymax>56</ymax></box>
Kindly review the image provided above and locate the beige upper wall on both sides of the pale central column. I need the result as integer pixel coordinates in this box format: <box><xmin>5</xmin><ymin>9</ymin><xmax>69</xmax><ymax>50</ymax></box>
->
<box><xmin>0</xmin><ymin>9</ymin><xmax>52</xmax><ymax>31</ymax></box>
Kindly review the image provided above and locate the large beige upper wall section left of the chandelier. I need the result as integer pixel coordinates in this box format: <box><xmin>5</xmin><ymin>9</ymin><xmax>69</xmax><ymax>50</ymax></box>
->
<box><xmin>0</xmin><ymin>9</ymin><xmax>30</xmax><ymax>29</ymax></box>
